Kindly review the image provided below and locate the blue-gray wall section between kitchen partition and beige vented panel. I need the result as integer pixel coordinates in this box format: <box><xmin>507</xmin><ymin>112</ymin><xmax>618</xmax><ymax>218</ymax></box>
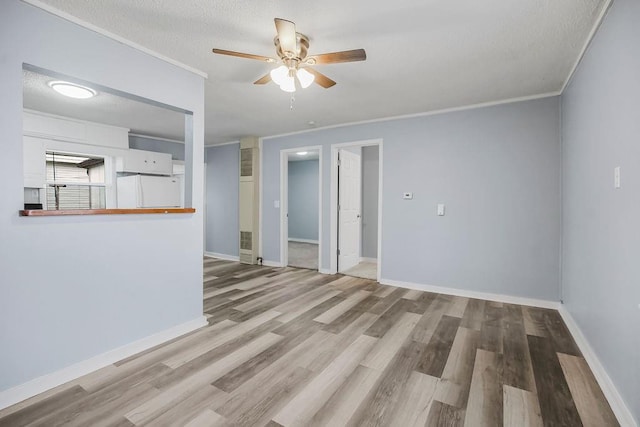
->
<box><xmin>205</xmin><ymin>143</ymin><xmax>240</xmax><ymax>257</ymax></box>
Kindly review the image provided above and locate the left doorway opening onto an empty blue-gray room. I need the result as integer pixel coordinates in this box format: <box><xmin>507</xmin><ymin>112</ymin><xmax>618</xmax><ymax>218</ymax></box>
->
<box><xmin>280</xmin><ymin>147</ymin><xmax>322</xmax><ymax>270</ymax></box>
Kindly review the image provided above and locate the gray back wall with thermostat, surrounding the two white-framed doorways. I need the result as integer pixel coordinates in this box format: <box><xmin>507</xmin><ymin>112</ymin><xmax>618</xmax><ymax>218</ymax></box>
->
<box><xmin>262</xmin><ymin>97</ymin><xmax>560</xmax><ymax>301</ymax></box>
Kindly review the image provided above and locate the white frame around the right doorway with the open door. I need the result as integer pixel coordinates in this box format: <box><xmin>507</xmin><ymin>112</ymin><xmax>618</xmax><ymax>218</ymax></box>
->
<box><xmin>329</xmin><ymin>138</ymin><xmax>383</xmax><ymax>282</ymax></box>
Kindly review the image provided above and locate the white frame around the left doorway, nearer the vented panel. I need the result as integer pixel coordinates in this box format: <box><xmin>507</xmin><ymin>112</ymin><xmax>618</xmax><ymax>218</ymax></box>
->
<box><xmin>280</xmin><ymin>145</ymin><xmax>322</xmax><ymax>271</ymax></box>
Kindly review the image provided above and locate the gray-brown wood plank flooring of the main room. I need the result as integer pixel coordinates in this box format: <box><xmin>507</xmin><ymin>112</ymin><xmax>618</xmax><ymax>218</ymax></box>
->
<box><xmin>0</xmin><ymin>258</ymin><xmax>618</xmax><ymax>427</ymax></box>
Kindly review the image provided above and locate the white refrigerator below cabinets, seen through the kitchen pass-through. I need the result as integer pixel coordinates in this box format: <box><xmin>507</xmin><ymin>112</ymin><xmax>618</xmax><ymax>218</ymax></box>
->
<box><xmin>116</xmin><ymin>175</ymin><xmax>182</xmax><ymax>209</ymax></box>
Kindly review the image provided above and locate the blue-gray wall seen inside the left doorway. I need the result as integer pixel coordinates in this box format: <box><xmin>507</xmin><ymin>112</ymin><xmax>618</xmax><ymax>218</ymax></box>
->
<box><xmin>288</xmin><ymin>160</ymin><xmax>320</xmax><ymax>240</ymax></box>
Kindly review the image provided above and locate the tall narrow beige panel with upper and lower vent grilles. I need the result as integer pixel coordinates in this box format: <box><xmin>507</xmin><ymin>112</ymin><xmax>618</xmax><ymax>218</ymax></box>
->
<box><xmin>239</xmin><ymin>136</ymin><xmax>260</xmax><ymax>264</ymax></box>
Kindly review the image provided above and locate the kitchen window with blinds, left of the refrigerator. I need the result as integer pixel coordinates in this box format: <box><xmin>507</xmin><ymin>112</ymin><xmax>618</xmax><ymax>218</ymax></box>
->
<box><xmin>46</xmin><ymin>151</ymin><xmax>106</xmax><ymax>210</ymax></box>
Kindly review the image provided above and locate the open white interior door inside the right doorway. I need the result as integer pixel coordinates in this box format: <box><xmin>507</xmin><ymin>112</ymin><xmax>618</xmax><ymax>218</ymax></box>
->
<box><xmin>338</xmin><ymin>150</ymin><xmax>362</xmax><ymax>271</ymax></box>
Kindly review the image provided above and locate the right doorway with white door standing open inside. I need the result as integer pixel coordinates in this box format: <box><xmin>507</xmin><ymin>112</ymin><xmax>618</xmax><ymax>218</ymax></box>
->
<box><xmin>331</xmin><ymin>140</ymin><xmax>382</xmax><ymax>281</ymax></box>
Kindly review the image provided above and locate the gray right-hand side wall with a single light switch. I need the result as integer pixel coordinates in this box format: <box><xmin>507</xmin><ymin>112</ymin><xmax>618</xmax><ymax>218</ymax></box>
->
<box><xmin>562</xmin><ymin>0</ymin><xmax>640</xmax><ymax>422</ymax></box>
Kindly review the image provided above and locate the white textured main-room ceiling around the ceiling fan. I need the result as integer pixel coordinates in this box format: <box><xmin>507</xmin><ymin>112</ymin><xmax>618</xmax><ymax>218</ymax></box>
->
<box><xmin>26</xmin><ymin>0</ymin><xmax>607</xmax><ymax>144</ymax></box>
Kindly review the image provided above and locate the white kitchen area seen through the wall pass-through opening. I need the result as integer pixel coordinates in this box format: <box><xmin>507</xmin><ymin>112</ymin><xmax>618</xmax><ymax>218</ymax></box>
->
<box><xmin>23</xmin><ymin>67</ymin><xmax>190</xmax><ymax>214</ymax></box>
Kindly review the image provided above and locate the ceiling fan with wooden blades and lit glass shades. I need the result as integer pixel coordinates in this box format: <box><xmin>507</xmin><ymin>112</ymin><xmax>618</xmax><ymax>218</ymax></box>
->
<box><xmin>213</xmin><ymin>18</ymin><xmax>367</xmax><ymax>92</ymax></box>
